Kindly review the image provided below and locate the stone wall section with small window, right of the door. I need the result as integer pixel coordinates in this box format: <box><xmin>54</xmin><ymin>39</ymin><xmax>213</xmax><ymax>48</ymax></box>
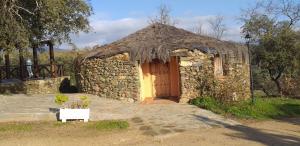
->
<box><xmin>176</xmin><ymin>50</ymin><xmax>250</xmax><ymax>102</ymax></box>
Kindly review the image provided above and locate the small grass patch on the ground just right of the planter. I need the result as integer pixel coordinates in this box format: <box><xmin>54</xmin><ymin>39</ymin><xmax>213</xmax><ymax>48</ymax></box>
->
<box><xmin>87</xmin><ymin>120</ymin><xmax>129</xmax><ymax>131</ymax></box>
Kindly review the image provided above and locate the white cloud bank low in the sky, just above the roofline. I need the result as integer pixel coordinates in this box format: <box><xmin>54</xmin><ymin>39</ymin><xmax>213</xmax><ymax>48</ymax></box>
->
<box><xmin>60</xmin><ymin>15</ymin><xmax>241</xmax><ymax>48</ymax></box>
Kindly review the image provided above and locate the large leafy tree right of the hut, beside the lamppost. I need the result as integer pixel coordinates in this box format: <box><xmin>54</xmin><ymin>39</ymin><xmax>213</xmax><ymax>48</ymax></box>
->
<box><xmin>241</xmin><ymin>0</ymin><xmax>300</xmax><ymax>95</ymax></box>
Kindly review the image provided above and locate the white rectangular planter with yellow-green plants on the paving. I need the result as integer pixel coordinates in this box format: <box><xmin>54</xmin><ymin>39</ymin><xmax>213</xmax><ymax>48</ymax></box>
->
<box><xmin>55</xmin><ymin>94</ymin><xmax>90</xmax><ymax>122</ymax></box>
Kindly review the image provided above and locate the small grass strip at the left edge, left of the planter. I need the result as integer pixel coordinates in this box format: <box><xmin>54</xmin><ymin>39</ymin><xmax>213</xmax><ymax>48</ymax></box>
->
<box><xmin>0</xmin><ymin>123</ymin><xmax>32</xmax><ymax>132</ymax></box>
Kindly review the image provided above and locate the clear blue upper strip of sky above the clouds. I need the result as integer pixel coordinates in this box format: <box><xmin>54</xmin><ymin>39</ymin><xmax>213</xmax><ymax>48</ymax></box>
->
<box><xmin>91</xmin><ymin>0</ymin><xmax>251</xmax><ymax>19</ymax></box>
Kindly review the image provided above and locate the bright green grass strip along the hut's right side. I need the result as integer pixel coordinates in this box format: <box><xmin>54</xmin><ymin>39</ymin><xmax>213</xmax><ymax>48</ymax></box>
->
<box><xmin>191</xmin><ymin>97</ymin><xmax>300</xmax><ymax>119</ymax></box>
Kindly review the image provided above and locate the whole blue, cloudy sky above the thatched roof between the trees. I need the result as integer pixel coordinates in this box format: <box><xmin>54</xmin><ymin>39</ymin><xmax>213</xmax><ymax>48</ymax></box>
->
<box><xmin>60</xmin><ymin>0</ymin><xmax>257</xmax><ymax>49</ymax></box>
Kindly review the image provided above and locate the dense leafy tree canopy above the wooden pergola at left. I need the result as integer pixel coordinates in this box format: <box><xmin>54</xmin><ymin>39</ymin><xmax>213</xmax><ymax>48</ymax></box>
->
<box><xmin>0</xmin><ymin>0</ymin><xmax>92</xmax><ymax>50</ymax></box>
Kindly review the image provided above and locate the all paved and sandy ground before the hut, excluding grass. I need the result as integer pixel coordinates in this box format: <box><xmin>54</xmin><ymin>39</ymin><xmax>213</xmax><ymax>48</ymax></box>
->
<box><xmin>0</xmin><ymin>94</ymin><xmax>300</xmax><ymax>146</ymax></box>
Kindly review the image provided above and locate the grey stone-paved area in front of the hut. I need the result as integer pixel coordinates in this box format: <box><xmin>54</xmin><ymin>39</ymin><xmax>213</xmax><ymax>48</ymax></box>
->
<box><xmin>0</xmin><ymin>94</ymin><xmax>239</xmax><ymax>136</ymax></box>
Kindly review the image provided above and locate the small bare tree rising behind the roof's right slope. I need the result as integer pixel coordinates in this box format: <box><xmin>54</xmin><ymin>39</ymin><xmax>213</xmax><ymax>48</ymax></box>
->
<box><xmin>208</xmin><ymin>15</ymin><xmax>227</xmax><ymax>39</ymax></box>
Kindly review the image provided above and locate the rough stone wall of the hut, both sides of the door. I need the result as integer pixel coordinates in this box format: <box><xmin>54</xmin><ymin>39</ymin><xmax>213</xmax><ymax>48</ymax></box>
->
<box><xmin>76</xmin><ymin>49</ymin><xmax>250</xmax><ymax>102</ymax></box>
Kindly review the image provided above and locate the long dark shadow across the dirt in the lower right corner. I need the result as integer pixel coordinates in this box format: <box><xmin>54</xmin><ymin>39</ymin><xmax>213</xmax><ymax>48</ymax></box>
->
<box><xmin>195</xmin><ymin>115</ymin><xmax>300</xmax><ymax>146</ymax></box>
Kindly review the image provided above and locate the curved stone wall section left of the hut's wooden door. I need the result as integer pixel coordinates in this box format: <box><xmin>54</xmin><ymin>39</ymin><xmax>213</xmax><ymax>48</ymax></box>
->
<box><xmin>76</xmin><ymin>53</ymin><xmax>140</xmax><ymax>102</ymax></box>
